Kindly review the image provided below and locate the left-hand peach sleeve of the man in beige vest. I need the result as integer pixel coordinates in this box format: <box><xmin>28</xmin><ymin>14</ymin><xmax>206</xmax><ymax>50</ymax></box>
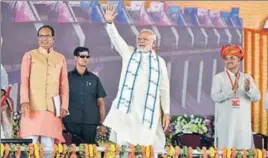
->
<box><xmin>20</xmin><ymin>52</ymin><xmax>31</xmax><ymax>104</ymax></box>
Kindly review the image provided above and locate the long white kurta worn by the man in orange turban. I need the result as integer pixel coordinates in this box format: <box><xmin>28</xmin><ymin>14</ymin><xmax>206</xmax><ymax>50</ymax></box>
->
<box><xmin>211</xmin><ymin>70</ymin><xmax>260</xmax><ymax>149</ymax></box>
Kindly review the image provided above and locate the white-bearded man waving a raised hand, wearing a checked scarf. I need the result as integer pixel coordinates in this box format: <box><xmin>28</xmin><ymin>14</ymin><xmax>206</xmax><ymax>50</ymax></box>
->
<box><xmin>103</xmin><ymin>5</ymin><xmax>170</xmax><ymax>149</ymax></box>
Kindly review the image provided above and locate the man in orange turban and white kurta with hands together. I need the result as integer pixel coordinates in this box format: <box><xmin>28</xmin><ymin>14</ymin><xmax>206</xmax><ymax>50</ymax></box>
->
<box><xmin>211</xmin><ymin>44</ymin><xmax>260</xmax><ymax>149</ymax></box>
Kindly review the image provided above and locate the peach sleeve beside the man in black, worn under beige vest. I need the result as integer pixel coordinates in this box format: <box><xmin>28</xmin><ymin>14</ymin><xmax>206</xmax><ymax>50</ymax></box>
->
<box><xmin>60</xmin><ymin>57</ymin><xmax>69</xmax><ymax>111</ymax></box>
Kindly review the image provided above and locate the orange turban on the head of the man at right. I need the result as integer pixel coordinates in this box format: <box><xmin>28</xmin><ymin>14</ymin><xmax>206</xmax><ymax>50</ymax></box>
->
<box><xmin>221</xmin><ymin>44</ymin><xmax>245</xmax><ymax>60</ymax></box>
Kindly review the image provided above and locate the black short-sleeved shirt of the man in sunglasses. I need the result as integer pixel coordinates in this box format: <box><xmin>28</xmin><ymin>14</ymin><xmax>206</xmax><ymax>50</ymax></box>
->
<box><xmin>63</xmin><ymin>69</ymin><xmax>106</xmax><ymax>125</ymax></box>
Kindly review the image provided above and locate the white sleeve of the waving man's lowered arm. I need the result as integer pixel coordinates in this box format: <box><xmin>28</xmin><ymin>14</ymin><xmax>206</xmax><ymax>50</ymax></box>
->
<box><xmin>160</xmin><ymin>59</ymin><xmax>170</xmax><ymax>114</ymax></box>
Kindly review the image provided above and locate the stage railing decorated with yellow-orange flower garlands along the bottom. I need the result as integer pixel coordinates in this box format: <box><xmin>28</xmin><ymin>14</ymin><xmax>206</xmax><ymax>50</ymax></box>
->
<box><xmin>0</xmin><ymin>144</ymin><xmax>268</xmax><ymax>158</ymax></box>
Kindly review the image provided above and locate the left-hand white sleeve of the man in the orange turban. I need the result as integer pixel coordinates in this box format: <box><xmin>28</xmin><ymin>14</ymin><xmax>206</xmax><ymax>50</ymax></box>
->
<box><xmin>211</xmin><ymin>75</ymin><xmax>234</xmax><ymax>103</ymax></box>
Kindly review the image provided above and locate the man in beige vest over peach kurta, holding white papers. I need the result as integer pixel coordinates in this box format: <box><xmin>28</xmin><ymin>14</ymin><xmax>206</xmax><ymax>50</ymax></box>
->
<box><xmin>20</xmin><ymin>25</ymin><xmax>69</xmax><ymax>147</ymax></box>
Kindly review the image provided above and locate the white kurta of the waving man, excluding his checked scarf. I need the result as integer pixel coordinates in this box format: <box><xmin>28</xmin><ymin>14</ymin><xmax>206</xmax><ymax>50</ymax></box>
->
<box><xmin>104</xmin><ymin>24</ymin><xmax>170</xmax><ymax>148</ymax></box>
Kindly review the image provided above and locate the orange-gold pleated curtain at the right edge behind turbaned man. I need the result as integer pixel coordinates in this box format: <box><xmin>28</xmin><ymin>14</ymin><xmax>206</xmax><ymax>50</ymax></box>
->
<box><xmin>244</xmin><ymin>28</ymin><xmax>268</xmax><ymax>135</ymax></box>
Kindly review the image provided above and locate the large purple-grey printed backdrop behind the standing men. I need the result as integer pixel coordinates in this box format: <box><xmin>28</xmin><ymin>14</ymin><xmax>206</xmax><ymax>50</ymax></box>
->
<box><xmin>1</xmin><ymin>1</ymin><xmax>243</xmax><ymax>123</ymax></box>
